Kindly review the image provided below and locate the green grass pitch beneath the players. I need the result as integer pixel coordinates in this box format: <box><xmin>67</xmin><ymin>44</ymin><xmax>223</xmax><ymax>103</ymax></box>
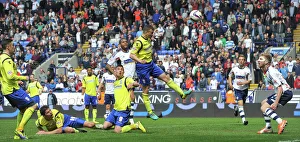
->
<box><xmin>0</xmin><ymin>117</ymin><xmax>300</xmax><ymax>142</ymax></box>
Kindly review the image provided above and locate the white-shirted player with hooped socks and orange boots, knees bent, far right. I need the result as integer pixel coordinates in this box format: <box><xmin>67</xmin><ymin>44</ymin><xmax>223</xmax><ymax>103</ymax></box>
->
<box><xmin>257</xmin><ymin>54</ymin><xmax>293</xmax><ymax>134</ymax></box>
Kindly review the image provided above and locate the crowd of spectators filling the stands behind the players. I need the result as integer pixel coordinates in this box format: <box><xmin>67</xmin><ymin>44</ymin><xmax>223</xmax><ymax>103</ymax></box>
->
<box><xmin>0</xmin><ymin>0</ymin><xmax>300</xmax><ymax>91</ymax></box>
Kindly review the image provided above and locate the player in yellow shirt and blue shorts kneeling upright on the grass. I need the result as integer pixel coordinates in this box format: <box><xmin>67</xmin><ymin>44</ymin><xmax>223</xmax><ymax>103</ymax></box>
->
<box><xmin>103</xmin><ymin>65</ymin><xmax>146</xmax><ymax>133</ymax></box>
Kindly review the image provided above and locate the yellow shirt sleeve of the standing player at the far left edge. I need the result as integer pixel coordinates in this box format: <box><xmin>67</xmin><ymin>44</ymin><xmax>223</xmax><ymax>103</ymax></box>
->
<box><xmin>3</xmin><ymin>60</ymin><xmax>27</xmax><ymax>81</ymax></box>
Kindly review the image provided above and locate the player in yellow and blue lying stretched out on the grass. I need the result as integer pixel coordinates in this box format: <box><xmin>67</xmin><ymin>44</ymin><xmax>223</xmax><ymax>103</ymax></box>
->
<box><xmin>35</xmin><ymin>105</ymin><xmax>101</xmax><ymax>134</ymax></box>
